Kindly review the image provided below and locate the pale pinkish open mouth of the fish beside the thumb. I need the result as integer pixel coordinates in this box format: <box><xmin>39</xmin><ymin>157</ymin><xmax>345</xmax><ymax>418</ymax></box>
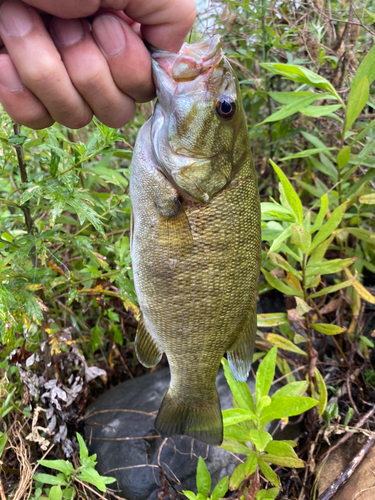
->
<box><xmin>151</xmin><ymin>35</ymin><xmax>224</xmax><ymax>82</ymax></box>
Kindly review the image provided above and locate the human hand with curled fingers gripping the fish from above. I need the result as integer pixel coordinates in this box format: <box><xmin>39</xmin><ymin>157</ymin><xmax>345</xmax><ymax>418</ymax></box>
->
<box><xmin>0</xmin><ymin>0</ymin><xmax>195</xmax><ymax>129</ymax></box>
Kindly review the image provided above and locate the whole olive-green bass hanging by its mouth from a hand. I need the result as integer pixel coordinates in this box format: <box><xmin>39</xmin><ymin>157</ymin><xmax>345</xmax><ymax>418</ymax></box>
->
<box><xmin>130</xmin><ymin>35</ymin><xmax>261</xmax><ymax>445</ymax></box>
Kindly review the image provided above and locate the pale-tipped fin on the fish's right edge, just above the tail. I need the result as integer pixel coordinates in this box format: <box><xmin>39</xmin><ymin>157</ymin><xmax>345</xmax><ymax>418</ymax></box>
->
<box><xmin>227</xmin><ymin>305</ymin><xmax>257</xmax><ymax>382</ymax></box>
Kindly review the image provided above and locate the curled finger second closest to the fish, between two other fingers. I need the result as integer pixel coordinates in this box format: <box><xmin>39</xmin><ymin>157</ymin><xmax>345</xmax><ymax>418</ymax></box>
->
<box><xmin>51</xmin><ymin>18</ymin><xmax>135</xmax><ymax>128</ymax></box>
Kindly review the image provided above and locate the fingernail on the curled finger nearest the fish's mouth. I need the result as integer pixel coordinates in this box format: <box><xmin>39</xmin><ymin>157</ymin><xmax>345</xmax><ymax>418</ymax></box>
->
<box><xmin>93</xmin><ymin>15</ymin><xmax>125</xmax><ymax>56</ymax></box>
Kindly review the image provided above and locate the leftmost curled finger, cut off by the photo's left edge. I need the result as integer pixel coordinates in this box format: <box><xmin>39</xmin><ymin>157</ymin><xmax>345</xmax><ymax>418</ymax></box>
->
<box><xmin>0</xmin><ymin>54</ymin><xmax>53</xmax><ymax>129</ymax></box>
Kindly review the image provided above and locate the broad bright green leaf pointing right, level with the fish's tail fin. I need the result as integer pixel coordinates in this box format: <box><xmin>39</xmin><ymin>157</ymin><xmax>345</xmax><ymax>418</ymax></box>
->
<box><xmin>260</xmin><ymin>396</ymin><xmax>318</xmax><ymax>425</ymax></box>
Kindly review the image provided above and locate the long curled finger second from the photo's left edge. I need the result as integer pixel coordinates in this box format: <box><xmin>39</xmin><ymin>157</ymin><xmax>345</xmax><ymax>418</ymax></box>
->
<box><xmin>0</xmin><ymin>1</ymin><xmax>92</xmax><ymax>128</ymax></box>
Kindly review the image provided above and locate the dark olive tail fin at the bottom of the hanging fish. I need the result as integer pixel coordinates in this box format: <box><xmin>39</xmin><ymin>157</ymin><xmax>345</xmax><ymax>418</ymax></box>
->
<box><xmin>155</xmin><ymin>388</ymin><xmax>223</xmax><ymax>446</ymax></box>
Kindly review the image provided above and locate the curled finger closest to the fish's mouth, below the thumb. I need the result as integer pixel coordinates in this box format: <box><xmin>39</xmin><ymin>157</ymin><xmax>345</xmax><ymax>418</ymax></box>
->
<box><xmin>92</xmin><ymin>14</ymin><xmax>155</xmax><ymax>102</ymax></box>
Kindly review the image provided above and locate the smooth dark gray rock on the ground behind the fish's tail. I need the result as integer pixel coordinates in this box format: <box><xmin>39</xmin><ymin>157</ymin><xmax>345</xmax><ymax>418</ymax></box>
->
<box><xmin>86</xmin><ymin>369</ymin><xmax>255</xmax><ymax>500</ymax></box>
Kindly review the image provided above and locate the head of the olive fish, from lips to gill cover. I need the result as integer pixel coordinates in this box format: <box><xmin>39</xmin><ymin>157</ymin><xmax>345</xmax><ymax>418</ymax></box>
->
<box><xmin>151</xmin><ymin>35</ymin><xmax>248</xmax><ymax>202</ymax></box>
